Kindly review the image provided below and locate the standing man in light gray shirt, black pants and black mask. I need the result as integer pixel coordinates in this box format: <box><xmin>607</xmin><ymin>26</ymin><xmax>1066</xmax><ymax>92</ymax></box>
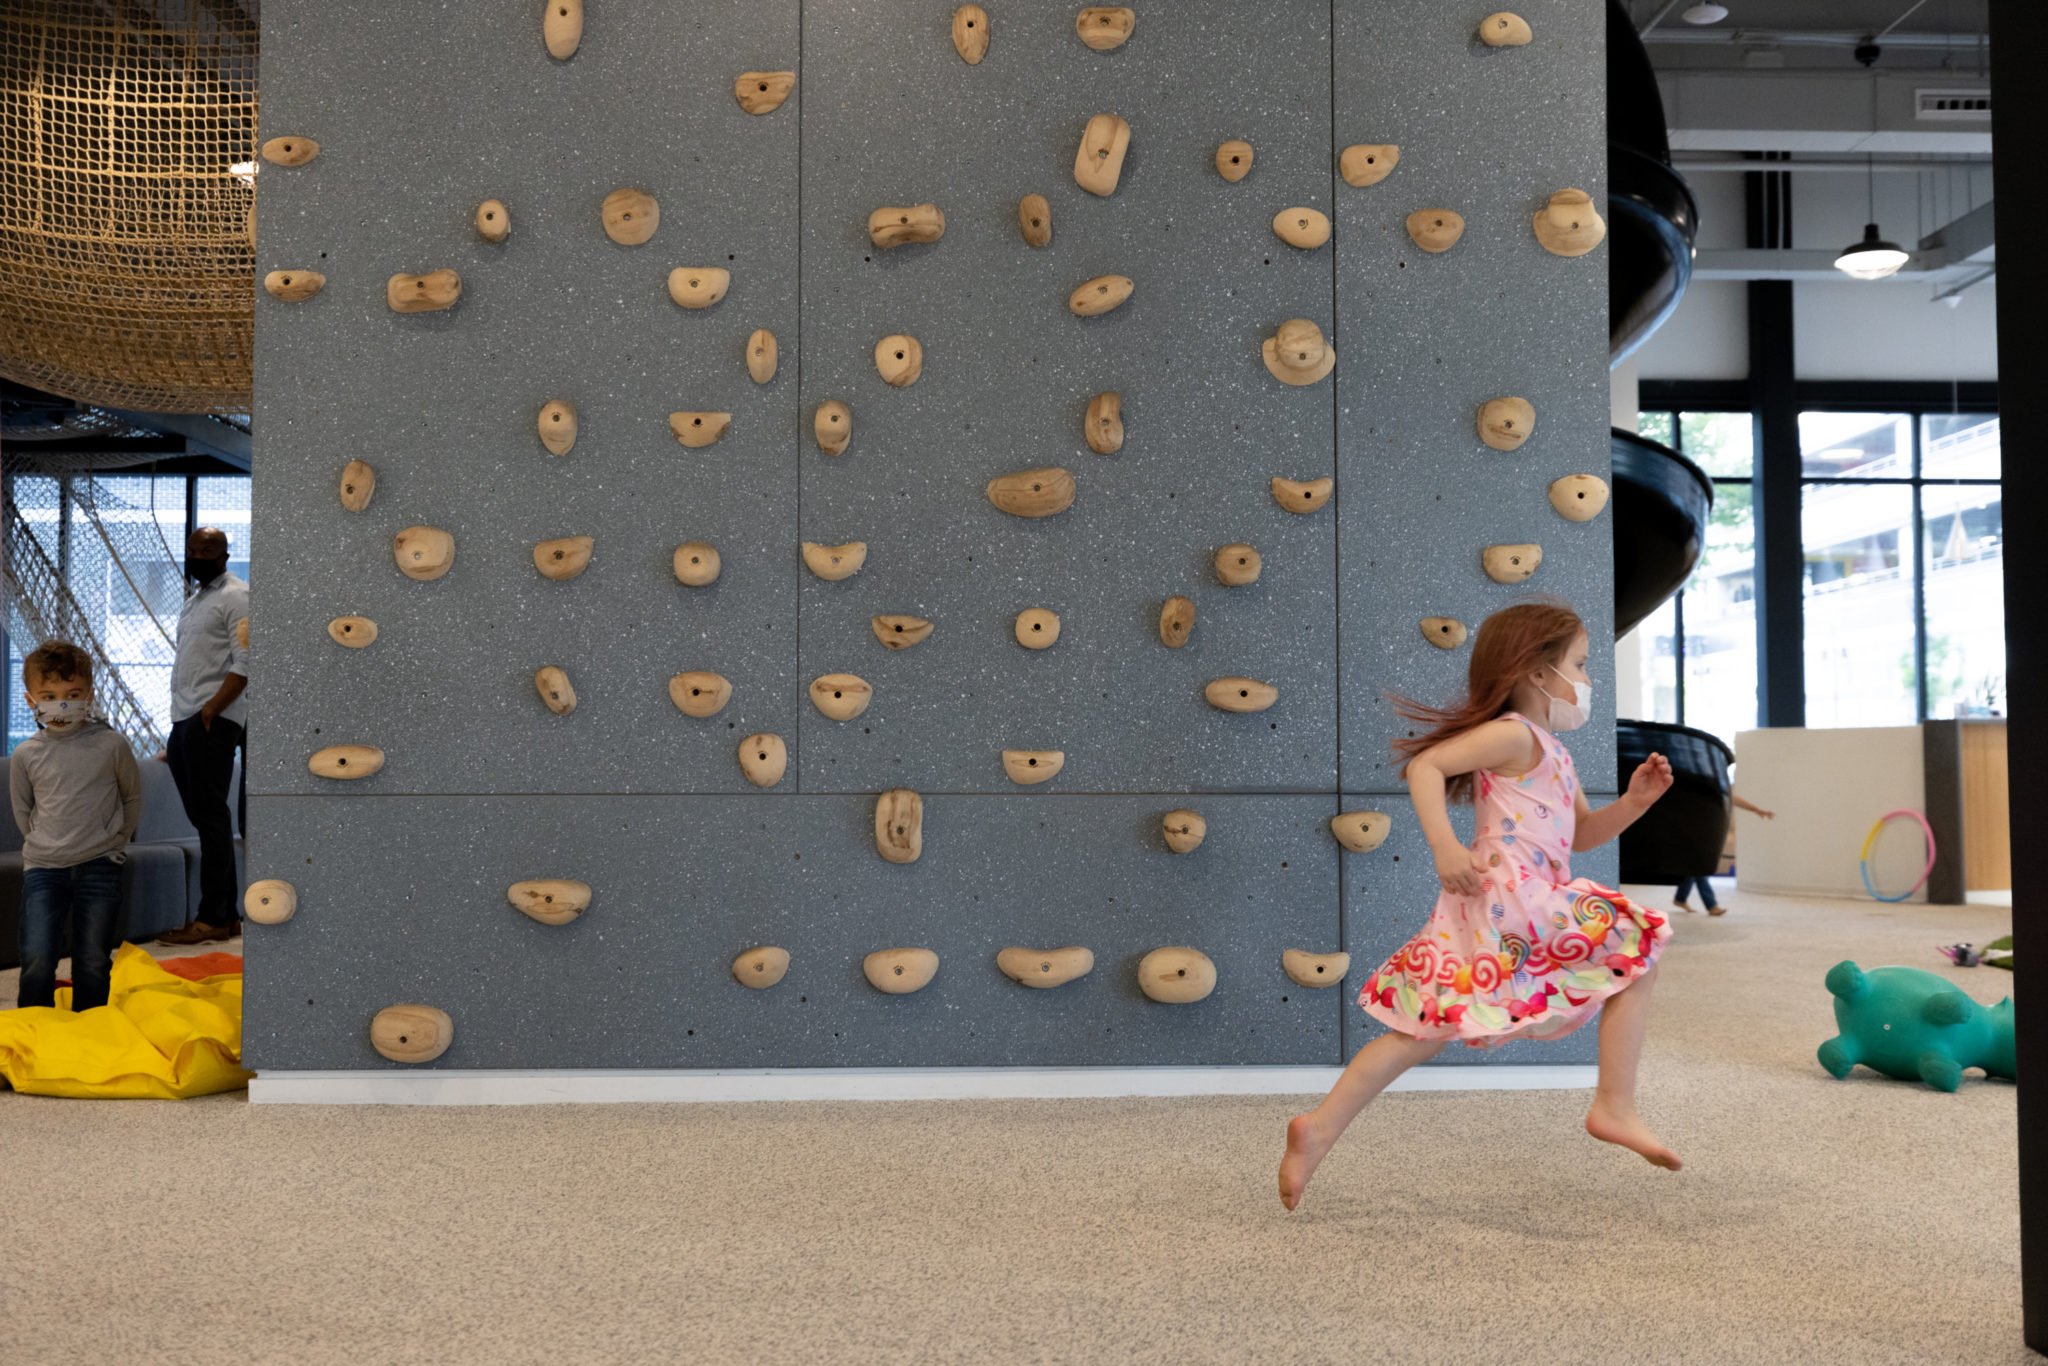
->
<box><xmin>158</xmin><ymin>526</ymin><xmax>250</xmax><ymax>944</ymax></box>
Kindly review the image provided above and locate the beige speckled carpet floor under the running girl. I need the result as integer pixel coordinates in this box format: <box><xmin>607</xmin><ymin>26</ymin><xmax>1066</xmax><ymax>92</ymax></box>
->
<box><xmin>0</xmin><ymin>897</ymin><xmax>2042</xmax><ymax>1366</ymax></box>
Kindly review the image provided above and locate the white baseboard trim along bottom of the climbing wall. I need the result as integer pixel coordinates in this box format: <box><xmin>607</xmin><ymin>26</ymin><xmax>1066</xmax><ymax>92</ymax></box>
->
<box><xmin>250</xmin><ymin>1063</ymin><xmax>1597</xmax><ymax>1106</ymax></box>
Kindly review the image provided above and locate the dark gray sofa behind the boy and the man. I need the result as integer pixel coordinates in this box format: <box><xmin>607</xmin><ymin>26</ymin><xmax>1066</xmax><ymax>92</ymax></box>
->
<box><xmin>0</xmin><ymin>756</ymin><xmax>246</xmax><ymax>969</ymax></box>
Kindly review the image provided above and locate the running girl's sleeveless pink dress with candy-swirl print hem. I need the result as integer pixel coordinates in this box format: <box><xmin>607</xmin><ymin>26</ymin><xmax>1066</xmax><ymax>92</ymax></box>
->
<box><xmin>1358</xmin><ymin>711</ymin><xmax>1671</xmax><ymax>1049</ymax></box>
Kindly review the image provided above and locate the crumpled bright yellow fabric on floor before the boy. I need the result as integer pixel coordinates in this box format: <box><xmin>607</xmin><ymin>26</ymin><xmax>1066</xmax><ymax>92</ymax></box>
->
<box><xmin>0</xmin><ymin>944</ymin><xmax>252</xmax><ymax>1100</ymax></box>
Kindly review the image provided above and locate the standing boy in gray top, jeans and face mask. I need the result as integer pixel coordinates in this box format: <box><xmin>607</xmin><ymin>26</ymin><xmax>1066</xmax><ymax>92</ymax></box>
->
<box><xmin>8</xmin><ymin>641</ymin><xmax>141</xmax><ymax>1010</ymax></box>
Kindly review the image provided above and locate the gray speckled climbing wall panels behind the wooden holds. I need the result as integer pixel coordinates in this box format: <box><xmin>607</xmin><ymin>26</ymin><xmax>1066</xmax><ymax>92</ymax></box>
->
<box><xmin>246</xmin><ymin>0</ymin><xmax>1614</xmax><ymax>1071</ymax></box>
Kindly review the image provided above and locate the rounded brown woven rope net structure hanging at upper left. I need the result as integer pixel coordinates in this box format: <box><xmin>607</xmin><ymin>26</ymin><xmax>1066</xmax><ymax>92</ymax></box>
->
<box><xmin>0</xmin><ymin>0</ymin><xmax>256</xmax><ymax>414</ymax></box>
